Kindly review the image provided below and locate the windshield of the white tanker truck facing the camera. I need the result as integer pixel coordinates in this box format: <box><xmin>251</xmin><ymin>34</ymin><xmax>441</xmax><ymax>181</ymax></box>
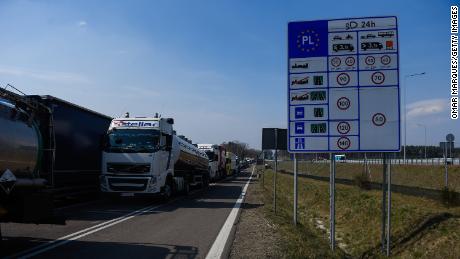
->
<box><xmin>105</xmin><ymin>129</ymin><xmax>160</xmax><ymax>153</ymax></box>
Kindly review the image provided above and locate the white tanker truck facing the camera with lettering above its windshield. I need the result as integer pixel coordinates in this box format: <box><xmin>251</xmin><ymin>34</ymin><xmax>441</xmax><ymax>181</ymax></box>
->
<box><xmin>100</xmin><ymin>117</ymin><xmax>210</xmax><ymax>199</ymax></box>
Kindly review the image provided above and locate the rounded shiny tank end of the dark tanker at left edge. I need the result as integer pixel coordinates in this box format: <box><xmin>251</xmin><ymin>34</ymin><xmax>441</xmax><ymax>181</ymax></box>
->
<box><xmin>0</xmin><ymin>99</ymin><xmax>42</xmax><ymax>180</ymax></box>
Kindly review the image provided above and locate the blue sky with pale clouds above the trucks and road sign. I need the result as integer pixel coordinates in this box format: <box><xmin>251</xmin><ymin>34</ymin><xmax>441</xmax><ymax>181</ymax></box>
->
<box><xmin>0</xmin><ymin>0</ymin><xmax>460</xmax><ymax>148</ymax></box>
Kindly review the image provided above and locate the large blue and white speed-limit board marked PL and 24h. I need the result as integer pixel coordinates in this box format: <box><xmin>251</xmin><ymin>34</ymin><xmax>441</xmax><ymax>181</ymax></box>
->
<box><xmin>287</xmin><ymin>16</ymin><xmax>400</xmax><ymax>153</ymax></box>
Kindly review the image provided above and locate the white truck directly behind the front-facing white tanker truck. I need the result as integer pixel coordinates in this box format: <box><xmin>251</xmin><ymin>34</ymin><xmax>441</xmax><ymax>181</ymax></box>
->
<box><xmin>198</xmin><ymin>144</ymin><xmax>226</xmax><ymax>181</ymax></box>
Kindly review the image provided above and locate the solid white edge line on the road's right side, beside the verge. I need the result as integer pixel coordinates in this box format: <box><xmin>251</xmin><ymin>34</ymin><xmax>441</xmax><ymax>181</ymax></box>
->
<box><xmin>206</xmin><ymin>166</ymin><xmax>255</xmax><ymax>259</ymax></box>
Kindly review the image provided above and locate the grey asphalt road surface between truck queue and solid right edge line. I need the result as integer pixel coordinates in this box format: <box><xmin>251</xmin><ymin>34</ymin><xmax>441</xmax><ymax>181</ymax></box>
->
<box><xmin>0</xmin><ymin>172</ymin><xmax>250</xmax><ymax>258</ymax></box>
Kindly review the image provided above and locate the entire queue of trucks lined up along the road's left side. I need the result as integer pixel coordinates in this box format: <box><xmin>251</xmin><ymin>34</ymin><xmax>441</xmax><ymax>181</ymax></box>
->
<box><xmin>0</xmin><ymin>89</ymin><xmax>244</xmax><ymax>228</ymax></box>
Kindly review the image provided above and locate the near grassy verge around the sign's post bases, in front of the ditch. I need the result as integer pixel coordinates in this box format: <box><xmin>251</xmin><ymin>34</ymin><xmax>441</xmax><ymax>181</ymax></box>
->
<box><xmin>260</xmin><ymin>170</ymin><xmax>460</xmax><ymax>258</ymax></box>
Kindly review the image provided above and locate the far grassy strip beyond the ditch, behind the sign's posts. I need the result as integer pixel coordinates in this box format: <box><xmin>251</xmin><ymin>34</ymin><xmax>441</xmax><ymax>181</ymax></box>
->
<box><xmin>266</xmin><ymin>161</ymin><xmax>460</xmax><ymax>192</ymax></box>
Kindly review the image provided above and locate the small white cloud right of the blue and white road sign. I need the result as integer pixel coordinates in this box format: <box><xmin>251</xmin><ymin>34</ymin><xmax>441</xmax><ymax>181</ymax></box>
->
<box><xmin>407</xmin><ymin>99</ymin><xmax>449</xmax><ymax>119</ymax></box>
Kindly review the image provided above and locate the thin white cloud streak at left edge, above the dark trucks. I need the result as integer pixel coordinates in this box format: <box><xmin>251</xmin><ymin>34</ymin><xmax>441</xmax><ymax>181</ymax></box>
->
<box><xmin>0</xmin><ymin>67</ymin><xmax>89</xmax><ymax>83</ymax></box>
